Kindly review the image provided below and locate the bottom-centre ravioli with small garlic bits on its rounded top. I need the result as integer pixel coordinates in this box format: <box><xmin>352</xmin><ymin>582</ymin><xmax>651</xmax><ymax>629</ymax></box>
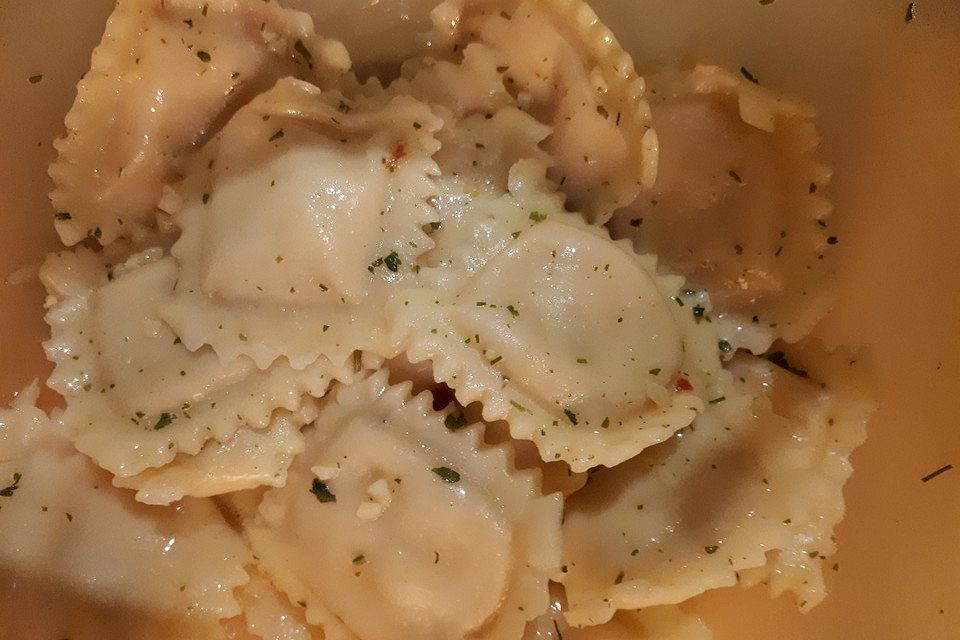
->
<box><xmin>245</xmin><ymin>372</ymin><xmax>561</xmax><ymax>640</ymax></box>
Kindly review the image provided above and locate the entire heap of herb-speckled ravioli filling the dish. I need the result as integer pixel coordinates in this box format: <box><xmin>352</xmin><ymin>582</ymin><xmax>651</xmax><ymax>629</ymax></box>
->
<box><xmin>9</xmin><ymin>0</ymin><xmax>873</xmax><ymax>640</ymax></box>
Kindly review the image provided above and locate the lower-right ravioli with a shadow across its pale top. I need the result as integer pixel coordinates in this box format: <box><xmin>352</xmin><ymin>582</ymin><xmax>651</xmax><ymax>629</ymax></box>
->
<box><xmin>563</xmin><ymin>348</ymin><xmax>873</xmax><ymax>626</ymax></box>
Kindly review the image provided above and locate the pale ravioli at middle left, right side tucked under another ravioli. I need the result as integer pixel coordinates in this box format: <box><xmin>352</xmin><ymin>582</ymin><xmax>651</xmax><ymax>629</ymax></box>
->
<box><xmin>41</xmin><ymin>249</ymin><xmax>342</xmax><ymax>480</ymax></box>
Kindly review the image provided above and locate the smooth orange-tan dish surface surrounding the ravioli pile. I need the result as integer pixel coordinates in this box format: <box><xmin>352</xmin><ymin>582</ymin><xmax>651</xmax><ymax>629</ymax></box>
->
<box><xmin>0</xmin><ymin>0</ymin><xmax>960</xmax><ymax>640</ymax></box>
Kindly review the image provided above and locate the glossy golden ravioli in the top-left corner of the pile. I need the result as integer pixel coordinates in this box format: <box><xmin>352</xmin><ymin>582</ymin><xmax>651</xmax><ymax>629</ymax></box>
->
<box><xmin>50</xmin><ymin>0</ymin><xmax>350</xmax><ymax>245</ymax></box>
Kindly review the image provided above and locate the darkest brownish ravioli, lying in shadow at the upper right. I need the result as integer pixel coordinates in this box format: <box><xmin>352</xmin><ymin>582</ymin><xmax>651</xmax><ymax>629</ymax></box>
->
<box><xmin>611</xmin><ymin>66</ymin><xmax>838</xmax><ymax>353</ymax></box>
